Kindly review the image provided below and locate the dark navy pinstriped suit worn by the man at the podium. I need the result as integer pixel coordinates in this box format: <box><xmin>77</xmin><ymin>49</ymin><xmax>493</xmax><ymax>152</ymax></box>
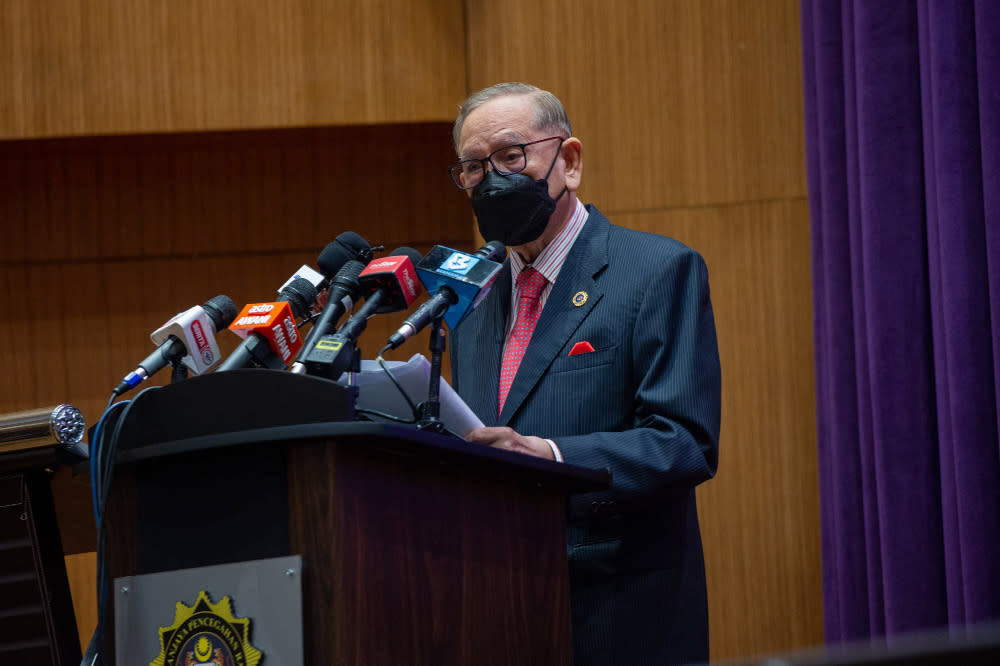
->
<box><xmin>451</xmin><ymin>205</ymin><xmax>720</xmax><ymax>666</ymax></box>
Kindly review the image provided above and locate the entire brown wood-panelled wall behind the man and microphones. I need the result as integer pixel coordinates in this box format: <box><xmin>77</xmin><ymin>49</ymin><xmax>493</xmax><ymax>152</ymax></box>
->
<box><xmin>0</xmin><ymin>0</ymin><xmax>822</xmax><ymax>658</ymax></box>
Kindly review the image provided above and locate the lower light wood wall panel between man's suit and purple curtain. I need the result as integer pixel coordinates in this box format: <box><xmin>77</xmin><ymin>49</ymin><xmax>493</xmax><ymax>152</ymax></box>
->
<box><xmin>615</xmin><ymin>199</ymin><xmax>823</xmax><ymax>657</ymax></box>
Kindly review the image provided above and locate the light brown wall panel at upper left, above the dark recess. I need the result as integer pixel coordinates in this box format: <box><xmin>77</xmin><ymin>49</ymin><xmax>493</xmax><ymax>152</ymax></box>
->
<box><xmin>0</xmin><ymin>0</ymin><xmax>465</xmax><ymax>138</ymax></box>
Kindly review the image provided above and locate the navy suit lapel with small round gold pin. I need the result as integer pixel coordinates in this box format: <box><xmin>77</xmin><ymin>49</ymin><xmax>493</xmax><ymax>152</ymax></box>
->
<box><xmin>500</xmin><ymin>208</ymin><xmax>609</xmax><ymax>425</ymax></box>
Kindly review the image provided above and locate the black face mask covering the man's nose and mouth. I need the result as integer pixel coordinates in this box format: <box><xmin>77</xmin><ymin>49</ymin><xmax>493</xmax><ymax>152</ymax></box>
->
<box><xmin>470</xmin><ymin>141</ymin><xmax>566</xmax><ymax>246</ymax></box>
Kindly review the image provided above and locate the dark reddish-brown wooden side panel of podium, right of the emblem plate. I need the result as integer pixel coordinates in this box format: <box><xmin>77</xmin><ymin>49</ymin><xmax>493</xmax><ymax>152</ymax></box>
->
<box><xmin>288</xmin><ymin>438</ymin><xmax>572</xmax><ymax>665</ymax></box>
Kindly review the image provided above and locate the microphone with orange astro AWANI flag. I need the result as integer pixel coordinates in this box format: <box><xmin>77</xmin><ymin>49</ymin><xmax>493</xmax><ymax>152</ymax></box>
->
<box><xmin>216</xmin><ymin>278</ymin><xmax>319</xmax><ymax>372</ymax></box>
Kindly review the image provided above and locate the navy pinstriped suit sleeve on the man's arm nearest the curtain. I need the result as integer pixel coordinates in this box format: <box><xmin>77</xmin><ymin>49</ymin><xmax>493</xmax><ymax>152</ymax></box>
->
<box><xmin>553</xmin><ymin>248</ymin><xmax>721</xmax><ymax>494</ymax></box>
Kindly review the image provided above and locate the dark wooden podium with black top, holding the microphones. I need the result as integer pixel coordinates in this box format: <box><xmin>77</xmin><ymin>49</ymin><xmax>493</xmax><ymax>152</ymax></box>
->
<box><xmin>106</xmin><ymin>370</ymin><xmax>609</xmax><ymax>666</ymax></box>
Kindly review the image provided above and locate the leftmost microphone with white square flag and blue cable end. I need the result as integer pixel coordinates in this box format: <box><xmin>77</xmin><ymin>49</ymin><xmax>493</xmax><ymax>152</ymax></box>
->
<box><xmin>112</xmin><ymin>295</ymin><xmax>236</xmax><ymax>396</ymax></box>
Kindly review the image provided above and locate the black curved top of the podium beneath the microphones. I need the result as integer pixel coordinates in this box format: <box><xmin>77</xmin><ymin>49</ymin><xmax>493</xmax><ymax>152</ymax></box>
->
<box><xmin>109</xmin><ymin>369</ymin><xmax>611</xmax><ymax>492</ymax></box>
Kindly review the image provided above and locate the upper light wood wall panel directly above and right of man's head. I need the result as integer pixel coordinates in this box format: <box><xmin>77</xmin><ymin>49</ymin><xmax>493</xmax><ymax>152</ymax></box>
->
<box><xmin>467</xmin><ymin>0</ymin><xmax>806</xmax><ymax>210</ymax></box>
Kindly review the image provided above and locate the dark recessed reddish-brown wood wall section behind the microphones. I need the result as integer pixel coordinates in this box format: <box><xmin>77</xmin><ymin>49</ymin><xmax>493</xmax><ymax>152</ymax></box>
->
<box><xmin>0</xmin><ymin>123</ymin><xmax>472</xmax><ymax>446</ymax></box>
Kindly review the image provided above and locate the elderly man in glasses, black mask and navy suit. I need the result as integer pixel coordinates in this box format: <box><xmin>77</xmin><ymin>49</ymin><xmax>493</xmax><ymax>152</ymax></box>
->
<box><xmin>450</xmin><ymin>83</ymin><xmax>720</xmax><ymax>665</ymax></box>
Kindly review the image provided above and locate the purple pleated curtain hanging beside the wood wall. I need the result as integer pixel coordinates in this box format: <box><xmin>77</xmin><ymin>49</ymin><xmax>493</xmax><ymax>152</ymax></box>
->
<box><xmin>801</xmin><ymin>0</ymin><xmax>1000</xmax><ymax>643</ymax></box>
